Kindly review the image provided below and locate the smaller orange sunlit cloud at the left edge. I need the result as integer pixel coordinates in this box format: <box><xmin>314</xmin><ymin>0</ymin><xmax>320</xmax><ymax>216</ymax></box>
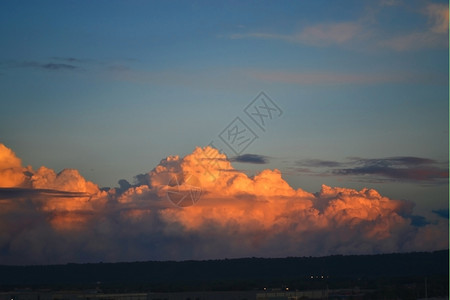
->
<box><xmin>0</xmin><ymin>144</ymin><xmax>106</xmax><ymax>230</ymax></box>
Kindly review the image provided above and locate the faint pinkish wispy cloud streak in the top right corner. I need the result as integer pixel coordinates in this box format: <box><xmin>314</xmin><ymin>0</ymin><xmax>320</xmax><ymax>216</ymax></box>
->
<box><xmin>228</xmin><ymin>0</ymin><xmax>449</xmax><ymax>51</ymax></box>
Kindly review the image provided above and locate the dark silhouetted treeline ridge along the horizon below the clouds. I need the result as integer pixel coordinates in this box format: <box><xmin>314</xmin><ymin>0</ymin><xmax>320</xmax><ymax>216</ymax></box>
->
<box><xmin>0</xmin><ymin>250</ymin><xmax>449</xmax><ymax>292</ymax></box>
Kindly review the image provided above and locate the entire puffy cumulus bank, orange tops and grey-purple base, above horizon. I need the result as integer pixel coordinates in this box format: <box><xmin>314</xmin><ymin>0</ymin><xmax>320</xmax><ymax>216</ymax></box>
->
<box><xmin>0</xmin><ymin>145</ymin><xmax>448</xmax><ymax>264</ymax></box>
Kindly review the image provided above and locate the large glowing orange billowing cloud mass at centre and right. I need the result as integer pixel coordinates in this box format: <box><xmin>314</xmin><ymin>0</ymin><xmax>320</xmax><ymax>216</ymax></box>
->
<box><xmin>124</xmin><ymin>147</ymin><xmax>440</xmax><ymax>252</ymax></box>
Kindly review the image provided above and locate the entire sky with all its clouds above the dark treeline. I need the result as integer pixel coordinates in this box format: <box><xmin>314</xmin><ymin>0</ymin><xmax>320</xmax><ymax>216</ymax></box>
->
<box><xmin>0</xmin><ymin>0</ymin><xmax>449</xmax><ymax>264</ymax></box>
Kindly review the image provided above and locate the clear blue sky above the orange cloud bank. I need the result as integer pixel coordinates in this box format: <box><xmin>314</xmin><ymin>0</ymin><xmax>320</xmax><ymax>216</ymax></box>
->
<box><xmin>0</xmin><ymin>0</ymin><xmax>449</xmax><ymax>223</ymax></box>
